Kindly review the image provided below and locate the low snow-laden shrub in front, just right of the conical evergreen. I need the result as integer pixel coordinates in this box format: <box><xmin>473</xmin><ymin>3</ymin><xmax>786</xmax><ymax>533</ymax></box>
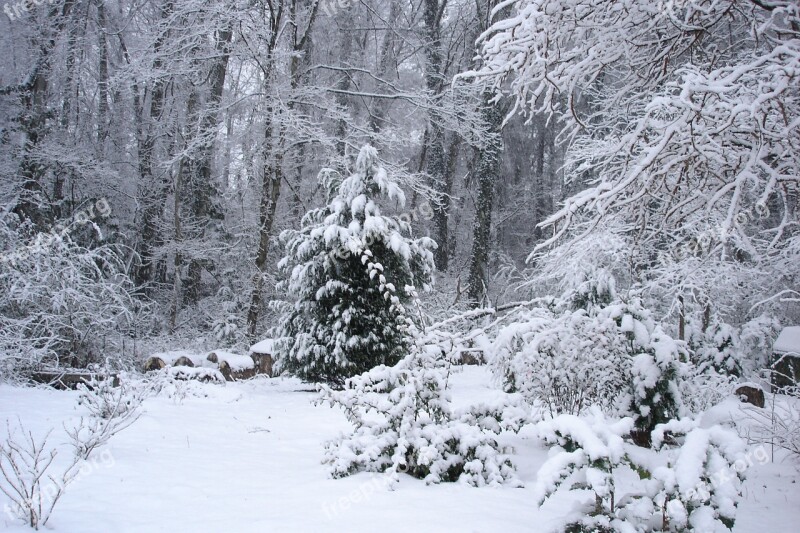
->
<box><xmin>320</xmin><ymin>346</ymin><xmax>527</xmax><ymax>486</ymax></box>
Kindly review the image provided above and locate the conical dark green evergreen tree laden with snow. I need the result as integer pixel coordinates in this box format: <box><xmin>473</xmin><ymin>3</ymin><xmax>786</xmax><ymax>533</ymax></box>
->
<box><xmin>276</xmin><ymin>145</ymin><xmax>436</xmax><ymax>385</ymax></box>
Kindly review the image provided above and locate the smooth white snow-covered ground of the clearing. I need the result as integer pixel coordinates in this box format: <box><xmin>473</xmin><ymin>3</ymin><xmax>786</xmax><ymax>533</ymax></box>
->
<box><xmin>0</xmin><ymin>367</ymin><xmax>800</xmax><ymax>533</ymax></box>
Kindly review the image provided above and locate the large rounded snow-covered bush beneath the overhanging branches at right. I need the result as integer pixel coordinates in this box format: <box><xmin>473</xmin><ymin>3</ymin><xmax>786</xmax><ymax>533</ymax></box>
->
<box><xmin>492</xmin><ymin>274</ymin><xmax>686</xmax><ymax>424</ymax></box>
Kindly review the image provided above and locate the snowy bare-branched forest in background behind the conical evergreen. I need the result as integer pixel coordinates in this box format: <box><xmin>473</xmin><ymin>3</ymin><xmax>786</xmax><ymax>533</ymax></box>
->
<box><xmin>0</xmin><ymin>0</ymin><xmax>800</xmax><ymax>375</ymax></box>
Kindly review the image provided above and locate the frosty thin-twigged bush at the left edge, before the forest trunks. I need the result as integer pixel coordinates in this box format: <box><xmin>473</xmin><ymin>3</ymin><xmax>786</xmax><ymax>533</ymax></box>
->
<box><xmin>0</xmin><ymin>217</ymin><xmax>133</xmax><ymax>375</ymax></box>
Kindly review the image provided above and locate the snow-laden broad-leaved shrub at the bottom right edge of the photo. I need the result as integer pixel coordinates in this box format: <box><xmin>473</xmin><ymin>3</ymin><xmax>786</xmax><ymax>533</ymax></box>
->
<box><xmin>536</xmin><ymin>409</ymin><xmax>747</xmax><ymax>533</ymax></box>
